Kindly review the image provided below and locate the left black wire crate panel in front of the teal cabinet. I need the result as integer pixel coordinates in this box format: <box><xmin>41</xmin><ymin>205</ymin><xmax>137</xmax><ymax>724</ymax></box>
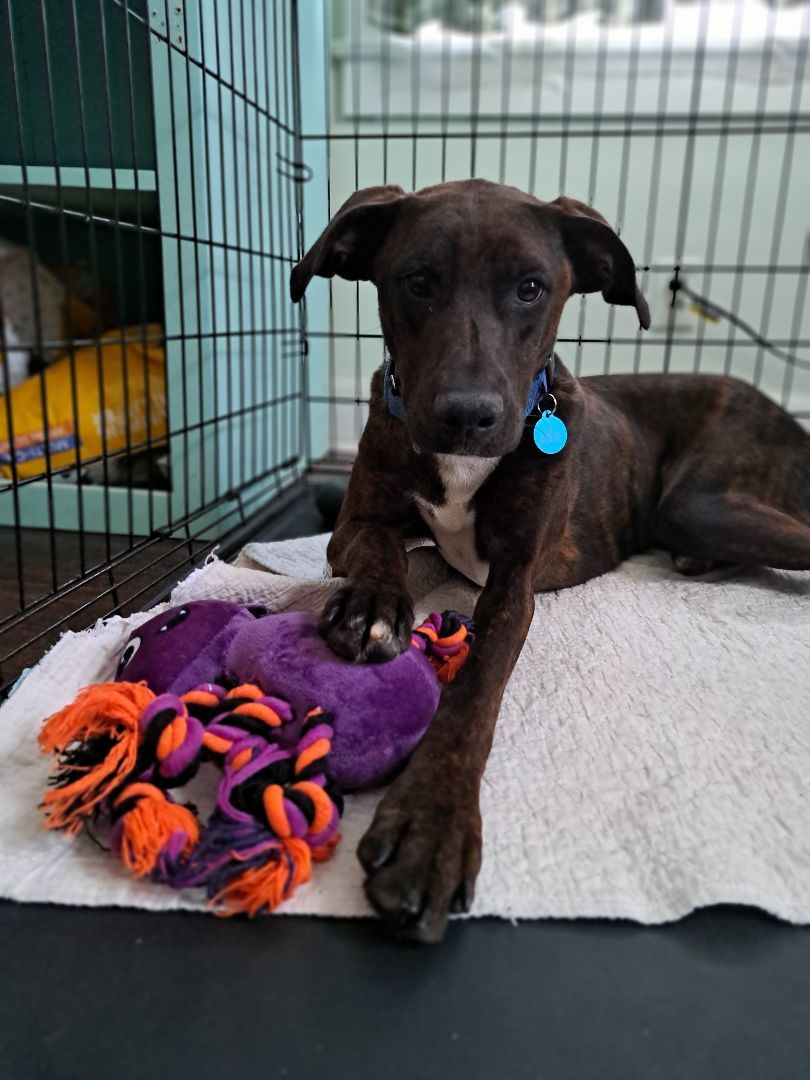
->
<box><xmin>0</xmin><ymin>0</ymin><xmax>308</xmax><ymax>685</ymax></box>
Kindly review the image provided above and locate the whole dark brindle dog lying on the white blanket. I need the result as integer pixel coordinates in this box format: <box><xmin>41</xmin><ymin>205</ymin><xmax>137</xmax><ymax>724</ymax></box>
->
<box><xmin>291</xmin><ymin>180</ymin><xmax>810</xmax><ymax>941</ymax></box>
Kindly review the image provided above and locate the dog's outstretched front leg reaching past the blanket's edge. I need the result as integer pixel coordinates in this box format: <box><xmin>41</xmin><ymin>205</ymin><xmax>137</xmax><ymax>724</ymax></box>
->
<box><xmin>359</xmin><ymin>563</ymin><xmax>535</xmax><ymax>942</ymax></box>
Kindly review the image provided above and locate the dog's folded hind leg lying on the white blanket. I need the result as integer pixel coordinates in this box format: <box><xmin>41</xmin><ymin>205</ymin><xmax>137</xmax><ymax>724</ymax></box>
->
<box><xmin>654</xmin><ymin>491</ymin><xmax>810</xmax><ymax>572</ymax></box>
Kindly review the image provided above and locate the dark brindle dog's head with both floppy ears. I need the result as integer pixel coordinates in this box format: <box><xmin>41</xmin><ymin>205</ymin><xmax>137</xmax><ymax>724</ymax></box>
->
<box><xmin>291</xmin><ymin>180</ymin><xmax>650</xmax><ymax>457</ymax></box>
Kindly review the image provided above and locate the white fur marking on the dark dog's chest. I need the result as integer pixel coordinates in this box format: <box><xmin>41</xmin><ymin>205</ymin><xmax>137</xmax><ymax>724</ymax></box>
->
<box><xmin>414</xmin><ymin>454</ymin><xmax>500</xmax><ymax>585</ymax></box>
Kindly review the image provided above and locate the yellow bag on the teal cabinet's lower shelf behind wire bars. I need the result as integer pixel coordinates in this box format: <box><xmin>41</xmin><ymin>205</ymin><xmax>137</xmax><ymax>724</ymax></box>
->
<box><xmin>0</xmin><ymin>325</ymin><xmax>166</xmax><ymax>477</ymax></box>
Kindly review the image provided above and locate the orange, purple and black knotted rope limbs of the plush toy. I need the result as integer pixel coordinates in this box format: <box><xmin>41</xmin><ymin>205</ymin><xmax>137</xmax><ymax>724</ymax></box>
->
<box><xmin>40</xmin><ymin>612</ymin><xmax>473</xmax><ymax>915</ymax></box>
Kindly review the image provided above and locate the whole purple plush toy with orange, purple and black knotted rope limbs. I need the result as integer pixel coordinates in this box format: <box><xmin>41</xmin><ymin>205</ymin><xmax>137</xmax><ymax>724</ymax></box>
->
<box><xmin>40</xmin><ymin>600</ymin><xmax>471</xmax><ymax>915</ymax></box>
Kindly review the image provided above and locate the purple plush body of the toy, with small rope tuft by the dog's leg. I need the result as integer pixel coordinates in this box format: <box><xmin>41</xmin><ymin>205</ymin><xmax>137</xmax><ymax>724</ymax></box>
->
<box><xmin>116</xmin><ymin>600</ymin><xmax>472</xmax><ymax>791</ymax></box>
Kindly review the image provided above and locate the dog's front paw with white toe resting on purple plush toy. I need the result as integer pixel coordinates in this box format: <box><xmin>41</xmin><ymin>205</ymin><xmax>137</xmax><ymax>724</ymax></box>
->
<box><xmin>318</xmin><ymin>585</ymin><xmax>414</xmax><ymax>663</ymax></box>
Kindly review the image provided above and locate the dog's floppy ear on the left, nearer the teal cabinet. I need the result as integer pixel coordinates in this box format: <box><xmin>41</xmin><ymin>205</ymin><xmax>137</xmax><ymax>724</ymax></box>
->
<box><xmin>289</xmin><ymin>184</ymin><xmax>407</xmax><ymax>303</ymax></box>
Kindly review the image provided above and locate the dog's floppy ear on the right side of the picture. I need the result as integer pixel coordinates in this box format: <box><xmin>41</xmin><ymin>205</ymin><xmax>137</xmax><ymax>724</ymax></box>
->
<box><xmin>546</xmin><ymin>195</ymin><xmax>650</xmax><ymax>329</ymax></box>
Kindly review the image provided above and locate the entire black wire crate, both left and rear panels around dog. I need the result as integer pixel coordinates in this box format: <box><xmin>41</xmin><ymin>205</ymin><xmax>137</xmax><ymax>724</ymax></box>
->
<box><xmin>0</xmin><ymin>0</ymin><xmax>810</xmax><ymax>685</ymax></box>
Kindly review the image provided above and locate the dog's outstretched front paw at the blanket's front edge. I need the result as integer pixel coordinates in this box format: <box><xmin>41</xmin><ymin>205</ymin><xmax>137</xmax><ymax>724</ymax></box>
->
<box><xmin>357</xmin><ymin>769</ymin><xmax>481</xmax><ymax>944</ymax></box>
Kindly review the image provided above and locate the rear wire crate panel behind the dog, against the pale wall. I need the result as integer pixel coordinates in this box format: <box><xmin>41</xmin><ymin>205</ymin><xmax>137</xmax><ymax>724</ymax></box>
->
<box><xmin>302</xmin><ymin>0</ymin><xmax>810</xmax><ymax>461</ymax></box>
